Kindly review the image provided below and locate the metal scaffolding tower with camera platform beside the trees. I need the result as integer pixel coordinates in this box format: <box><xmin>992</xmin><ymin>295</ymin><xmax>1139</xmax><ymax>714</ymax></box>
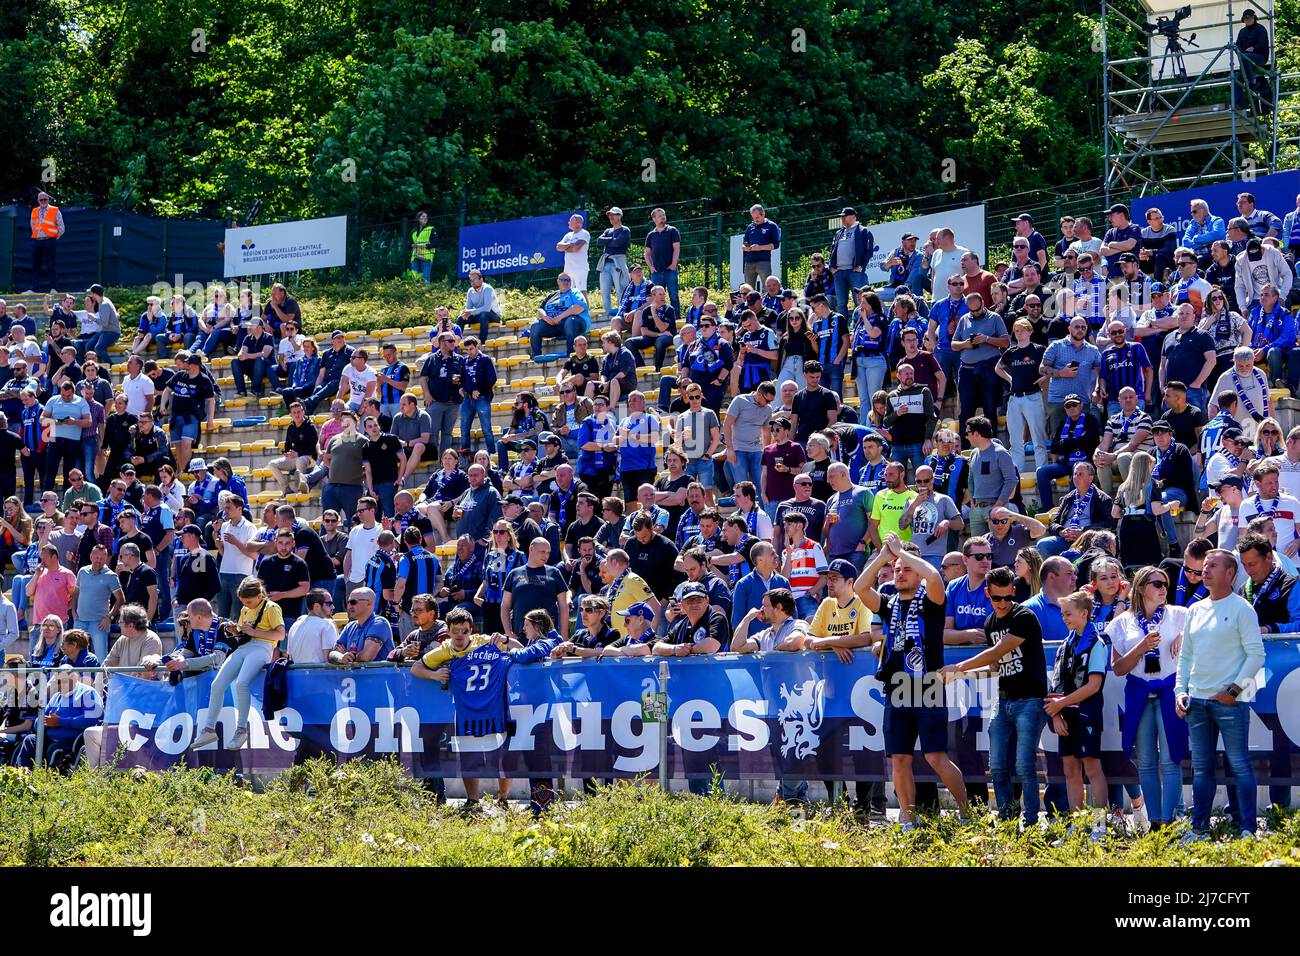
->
<box><xmin>1101</xmin><ymin>0</ymin><xmax>1292</xmax><ymax>203</ymax></box>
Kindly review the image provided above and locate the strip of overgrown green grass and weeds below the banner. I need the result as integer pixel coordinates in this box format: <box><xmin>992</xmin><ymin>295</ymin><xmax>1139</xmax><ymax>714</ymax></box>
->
<box><xmin>0</xmin><ymin>761</ymin><xmax>1300</xmax><ymax>866</ymax></box>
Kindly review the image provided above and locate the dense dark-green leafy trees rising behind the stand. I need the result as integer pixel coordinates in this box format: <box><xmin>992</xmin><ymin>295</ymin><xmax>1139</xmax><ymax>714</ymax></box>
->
<box><xmin>0</xmin><ymin>0</ymin><xmax>1295</xmax><ymax>222</ymax></box>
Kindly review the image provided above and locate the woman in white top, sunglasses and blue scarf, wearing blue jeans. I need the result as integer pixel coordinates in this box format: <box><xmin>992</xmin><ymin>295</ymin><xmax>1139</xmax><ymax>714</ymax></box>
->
<box><xmin>1106</xmin><ymin>567</ymin><xmax>1187</xmax><ymax>829</ymax></box>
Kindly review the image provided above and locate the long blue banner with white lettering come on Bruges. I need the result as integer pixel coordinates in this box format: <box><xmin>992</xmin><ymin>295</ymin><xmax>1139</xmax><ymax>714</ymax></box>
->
<box><xmin>103</xmin><ymin>640</ymin><xmax>1300</xmax><ymax>786</ymax></box>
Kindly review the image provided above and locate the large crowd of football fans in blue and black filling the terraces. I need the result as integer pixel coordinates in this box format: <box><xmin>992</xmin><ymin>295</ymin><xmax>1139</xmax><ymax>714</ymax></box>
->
<box><xmin>0</xmin><ymin>194</ymin><xmax>1300</xmax><ymax>835</ymax></box>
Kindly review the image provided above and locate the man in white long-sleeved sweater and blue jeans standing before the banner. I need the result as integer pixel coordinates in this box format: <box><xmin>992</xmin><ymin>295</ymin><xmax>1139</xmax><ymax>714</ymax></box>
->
<box><xmin>1174</xmin><ymin>550</ymin><xmax>1264</xmax><ymax>840</ymax></box>
